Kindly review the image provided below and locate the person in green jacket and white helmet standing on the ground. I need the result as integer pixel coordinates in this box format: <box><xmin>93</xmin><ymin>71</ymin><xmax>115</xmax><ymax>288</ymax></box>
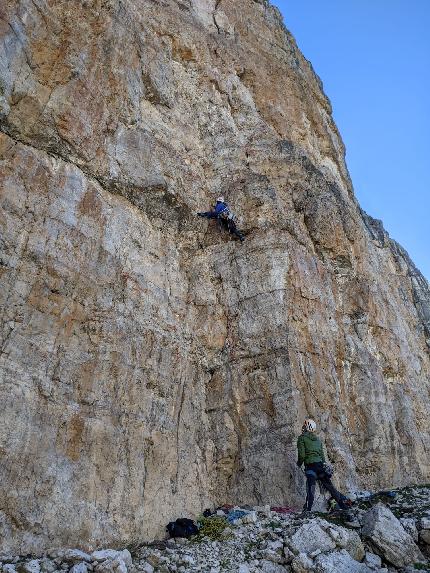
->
<box><xmin>297</xmin><ymin>419</ymin><xmax>348</xmax><ymax>511</ymax></box>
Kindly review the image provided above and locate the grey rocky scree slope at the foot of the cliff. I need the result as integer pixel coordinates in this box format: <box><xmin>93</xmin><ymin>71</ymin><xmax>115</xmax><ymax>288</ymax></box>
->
<box><xmin>0</xmin><ymin>487</ymin><xmax>430</xmax><ymax>573</ymax></box>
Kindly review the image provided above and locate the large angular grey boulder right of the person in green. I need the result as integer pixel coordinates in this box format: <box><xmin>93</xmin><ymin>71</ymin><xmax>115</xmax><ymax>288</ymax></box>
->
<box><xmin>362</xmin><ymin>503</ymin><xmax>423</xmax><ymax>567</ymax></box>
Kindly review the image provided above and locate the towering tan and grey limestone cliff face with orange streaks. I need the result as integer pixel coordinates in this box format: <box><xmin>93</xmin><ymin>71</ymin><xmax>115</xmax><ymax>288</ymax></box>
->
<box><xmin>0</xmin><ymin>0</ymin><xmax>430</xmax><ymax>553</ymax></box>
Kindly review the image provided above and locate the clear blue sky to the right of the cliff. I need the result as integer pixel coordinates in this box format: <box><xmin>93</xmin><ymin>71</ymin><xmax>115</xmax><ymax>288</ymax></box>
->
<box><xmin>272</xmin><ymin>0</ymin><xmax>430</xmax><ymax>279</ymax></box>
